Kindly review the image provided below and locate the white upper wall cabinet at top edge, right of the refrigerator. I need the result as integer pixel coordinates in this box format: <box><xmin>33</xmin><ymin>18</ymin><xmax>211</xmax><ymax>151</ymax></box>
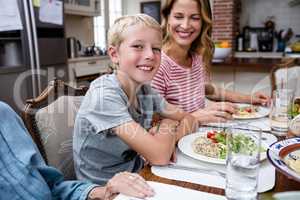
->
<box><xmin>64</xmin><ymin>0</ymin><xmax>101</xmax><ymax>16</ymax></box>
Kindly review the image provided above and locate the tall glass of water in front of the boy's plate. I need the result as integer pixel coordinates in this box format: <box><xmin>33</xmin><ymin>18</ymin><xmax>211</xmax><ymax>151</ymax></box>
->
<box><xmin>225</xmin><ymin>125</ymin><xmax>262</xmax><ymax>200</ymax></box>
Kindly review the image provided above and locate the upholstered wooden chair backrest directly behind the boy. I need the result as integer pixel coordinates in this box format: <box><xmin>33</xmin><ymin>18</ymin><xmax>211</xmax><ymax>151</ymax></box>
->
<box><xmin>22</xmin><ymin>80</ymin><xmax>88</xmax><ymax>179</ymax></box>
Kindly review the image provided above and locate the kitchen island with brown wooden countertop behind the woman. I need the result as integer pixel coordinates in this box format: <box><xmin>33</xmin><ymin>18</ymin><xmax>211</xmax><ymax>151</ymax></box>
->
<box><xmin>211</xmin><ymin>58</ymin><xmax>281</xmax><ymax>95</ymax></box>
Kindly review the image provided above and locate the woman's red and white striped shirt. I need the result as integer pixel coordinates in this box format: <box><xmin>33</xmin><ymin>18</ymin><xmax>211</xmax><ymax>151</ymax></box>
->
<box><xmin>151</xmin><ymin>52</ymin><xmax>206</xmax><ymax>112</ymax></box>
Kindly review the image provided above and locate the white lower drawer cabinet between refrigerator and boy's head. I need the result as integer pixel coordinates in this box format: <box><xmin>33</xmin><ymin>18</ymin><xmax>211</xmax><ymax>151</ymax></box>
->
<box><xmin>68</xmin><ymin>56</ymin><xmax>110</xmax><ymax>87</ymax></box>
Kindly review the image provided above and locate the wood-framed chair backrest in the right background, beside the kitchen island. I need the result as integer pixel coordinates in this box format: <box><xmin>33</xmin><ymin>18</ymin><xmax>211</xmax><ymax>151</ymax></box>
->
<box><xmin>271</xmin><ymin>58</ymin><xmax>300</xmax><ymax>91</ymax></box>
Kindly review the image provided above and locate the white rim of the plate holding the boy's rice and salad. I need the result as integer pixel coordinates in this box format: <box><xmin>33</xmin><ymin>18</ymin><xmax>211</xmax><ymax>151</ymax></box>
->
<box><xmin>178</xmin><ymin>132</ymin><xmax>277</xmax><ymax>165</ymax></box>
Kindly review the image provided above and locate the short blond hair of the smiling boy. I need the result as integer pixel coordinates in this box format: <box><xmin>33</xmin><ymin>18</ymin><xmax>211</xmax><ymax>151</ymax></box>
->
<box><xmin>107</xmin><ymin>14</ymin><xmax>162</xmax><ymax>47</ymax></box>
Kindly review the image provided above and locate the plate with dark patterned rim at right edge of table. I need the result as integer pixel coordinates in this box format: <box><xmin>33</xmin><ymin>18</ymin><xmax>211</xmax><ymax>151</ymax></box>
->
<box><xmin>267</xmin><ymin>137</ymin><xmax>300</xmax><ymax>182</ymax></box>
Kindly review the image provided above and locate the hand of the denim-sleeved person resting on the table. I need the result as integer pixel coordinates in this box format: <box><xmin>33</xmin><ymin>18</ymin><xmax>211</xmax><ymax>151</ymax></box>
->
<box><xmin>105</xmin><ymin>172</ymin><xmax>155</xmax><ymax>199</ymax></box>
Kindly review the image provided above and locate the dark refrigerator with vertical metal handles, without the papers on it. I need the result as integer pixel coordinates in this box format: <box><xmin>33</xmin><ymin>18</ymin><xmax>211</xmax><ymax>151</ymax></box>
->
<box><xmin>0</xmin><ymin>0</ymin><xmax>68</xmax><ymax>114</ymax></box>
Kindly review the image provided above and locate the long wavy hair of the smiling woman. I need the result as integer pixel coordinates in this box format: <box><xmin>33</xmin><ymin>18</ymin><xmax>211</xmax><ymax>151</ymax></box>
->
<box><xmin>161</xmin><ymin>0</ymin><xmax>214</xmax><ymax>75</ymax></box>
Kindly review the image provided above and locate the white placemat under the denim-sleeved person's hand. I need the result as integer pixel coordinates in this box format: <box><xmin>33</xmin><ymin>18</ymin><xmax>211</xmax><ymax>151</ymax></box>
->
<box><xmin>114</xmin><ymin>181</ymin><xmax>226</xmax><ymax>200</ymax></box>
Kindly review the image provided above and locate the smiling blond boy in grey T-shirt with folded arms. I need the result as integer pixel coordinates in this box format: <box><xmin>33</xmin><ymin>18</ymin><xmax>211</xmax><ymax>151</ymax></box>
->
<box><xmin>73</xmin><ymin>14</ymin><xmax>197</xmax><ymax>185</ymax></box>
